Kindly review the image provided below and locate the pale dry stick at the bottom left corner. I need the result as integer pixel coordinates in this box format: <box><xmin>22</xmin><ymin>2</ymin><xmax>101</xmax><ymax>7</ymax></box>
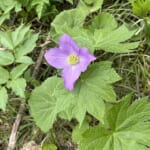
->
<box><xmin>7</xmin><ymin>103</ymin><xmax>25</xmax><ymax>150</ymax></box>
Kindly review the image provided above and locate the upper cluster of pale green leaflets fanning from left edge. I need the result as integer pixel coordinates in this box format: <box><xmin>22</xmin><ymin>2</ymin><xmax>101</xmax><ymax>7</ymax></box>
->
<box><xmin>0</xmin><ymin>24</ymin><xmax>38</xmax><ymax>65</ymax></box>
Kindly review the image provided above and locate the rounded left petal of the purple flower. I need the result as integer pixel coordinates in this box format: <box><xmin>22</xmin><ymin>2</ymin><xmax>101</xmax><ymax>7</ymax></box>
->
<box><xmin>44</xmin><ymin>48</ymin><xmax>67</xmax><ymax>69</ymax></box>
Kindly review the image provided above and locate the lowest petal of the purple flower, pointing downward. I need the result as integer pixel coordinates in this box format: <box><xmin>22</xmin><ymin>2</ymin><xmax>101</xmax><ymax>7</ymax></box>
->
<box><xmin>62</xmin><ymin>65</ymin><xmax>81</xmax><ymax>91</ymax></box>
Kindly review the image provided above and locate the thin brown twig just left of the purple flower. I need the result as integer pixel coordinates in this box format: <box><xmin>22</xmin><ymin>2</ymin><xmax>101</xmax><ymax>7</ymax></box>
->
<box><xmin>32</xmin><ymin>34</ymin><xmax>50</xmax><ymax>78</ymax></box>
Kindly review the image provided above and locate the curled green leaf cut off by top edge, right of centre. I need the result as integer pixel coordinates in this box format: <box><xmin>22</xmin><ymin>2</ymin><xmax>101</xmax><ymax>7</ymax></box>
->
<box><xmin>78</xmin><ymin>0</ymin><xmax>103</xmax><ymax>13</ymax></box>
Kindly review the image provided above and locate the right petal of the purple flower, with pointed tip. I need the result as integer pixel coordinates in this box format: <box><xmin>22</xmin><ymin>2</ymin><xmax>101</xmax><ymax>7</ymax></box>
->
<box><xmin>78</xmin><ymin>48</ymin><xmax>96</xmax><ymax>72</ymax></box>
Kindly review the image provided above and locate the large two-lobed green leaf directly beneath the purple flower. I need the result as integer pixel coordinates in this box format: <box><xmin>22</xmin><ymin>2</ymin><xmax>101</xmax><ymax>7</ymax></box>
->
<box><xmin>29</xmin><ymin>62</ymin><xmax>120</xmax><ymax>132</ymax></box>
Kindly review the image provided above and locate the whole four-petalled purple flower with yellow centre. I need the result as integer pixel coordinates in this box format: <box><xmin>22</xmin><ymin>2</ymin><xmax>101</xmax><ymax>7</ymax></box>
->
<box><xmin>45</xmin><ymin>34</ymin><xmax>96</xmax><ymax>91</ymax></box>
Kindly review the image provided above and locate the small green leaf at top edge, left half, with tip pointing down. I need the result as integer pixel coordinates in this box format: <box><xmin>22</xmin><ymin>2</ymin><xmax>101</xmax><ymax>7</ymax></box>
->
<box><xmin>31</xmin><ymin>0</ymin><xmax>49</xmax><ymax>19</ymax></box>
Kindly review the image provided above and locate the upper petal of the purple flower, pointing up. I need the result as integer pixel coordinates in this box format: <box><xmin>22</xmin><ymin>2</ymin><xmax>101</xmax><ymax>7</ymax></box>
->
<box><xmin>59</xmin><ymin>34</ymin><xmax>79</xmax><ymax>55</ymax></box>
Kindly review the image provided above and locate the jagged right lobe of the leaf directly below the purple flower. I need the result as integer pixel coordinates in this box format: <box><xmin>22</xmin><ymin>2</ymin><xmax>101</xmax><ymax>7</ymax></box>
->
<box><xmin>60</xmin><ymin>62</ymin><xmax>120</xmax><ymax>125</ymax></box>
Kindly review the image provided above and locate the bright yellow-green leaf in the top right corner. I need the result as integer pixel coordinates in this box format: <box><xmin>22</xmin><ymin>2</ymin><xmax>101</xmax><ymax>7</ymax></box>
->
<box><xmin>130</xmin><ymin>0</ymin><xmax>150</xmax><ymax>18</ymax></box>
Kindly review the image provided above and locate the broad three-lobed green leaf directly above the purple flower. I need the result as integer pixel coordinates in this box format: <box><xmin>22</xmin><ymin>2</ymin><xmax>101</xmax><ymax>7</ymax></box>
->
<box><xmin>51</xmin><ymin>9</ymin><xmax>139</xmax><ymax>53</ymax></box>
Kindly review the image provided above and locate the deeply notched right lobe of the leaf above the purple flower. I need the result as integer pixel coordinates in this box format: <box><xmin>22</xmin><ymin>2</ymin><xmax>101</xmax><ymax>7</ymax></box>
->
<box><xmin>94</xmin><ymin>25</ymin><xmax>139</xmax><ymax>53</ymax></box>
